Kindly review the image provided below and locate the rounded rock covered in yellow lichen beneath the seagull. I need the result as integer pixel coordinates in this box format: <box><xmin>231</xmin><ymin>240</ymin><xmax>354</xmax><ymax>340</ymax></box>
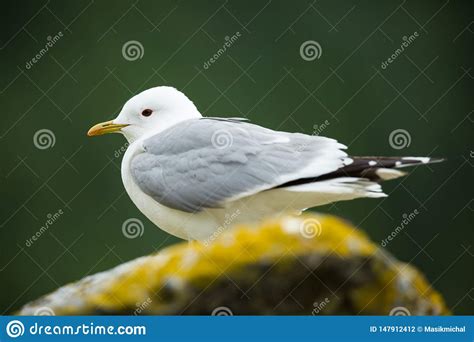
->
<box><xmin>18</xmin><ymin>215</ymin><xmax>449</xmax><ymax>315</ymax></box>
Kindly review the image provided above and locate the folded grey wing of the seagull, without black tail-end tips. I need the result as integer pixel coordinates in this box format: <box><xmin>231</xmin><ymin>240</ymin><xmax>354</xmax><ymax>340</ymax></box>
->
<box><xmin>131</xmin><ymin>119</ymin><xmax>347</xmax><ymax>212</ymax></box>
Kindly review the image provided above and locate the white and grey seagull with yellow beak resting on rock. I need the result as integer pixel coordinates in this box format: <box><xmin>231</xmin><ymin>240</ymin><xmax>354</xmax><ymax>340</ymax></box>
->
<box><xmin>87</xmin><ymin>86</ymin><xmax>442</xmax><ymax>240</ymax></box>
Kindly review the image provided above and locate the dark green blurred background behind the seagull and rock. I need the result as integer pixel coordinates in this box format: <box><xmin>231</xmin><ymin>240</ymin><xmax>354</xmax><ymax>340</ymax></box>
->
<box><xmin>0</xmin><ymin>0</ymin><xmax>474</xmax><ymax>314</ymax></box>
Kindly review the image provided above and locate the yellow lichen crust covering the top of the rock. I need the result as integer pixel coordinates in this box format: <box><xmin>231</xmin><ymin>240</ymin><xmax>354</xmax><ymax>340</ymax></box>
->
<box><xmin>17</xmin><ymin>215</ymin><xmax>448</xmax><ymax>314</ymax></box>
